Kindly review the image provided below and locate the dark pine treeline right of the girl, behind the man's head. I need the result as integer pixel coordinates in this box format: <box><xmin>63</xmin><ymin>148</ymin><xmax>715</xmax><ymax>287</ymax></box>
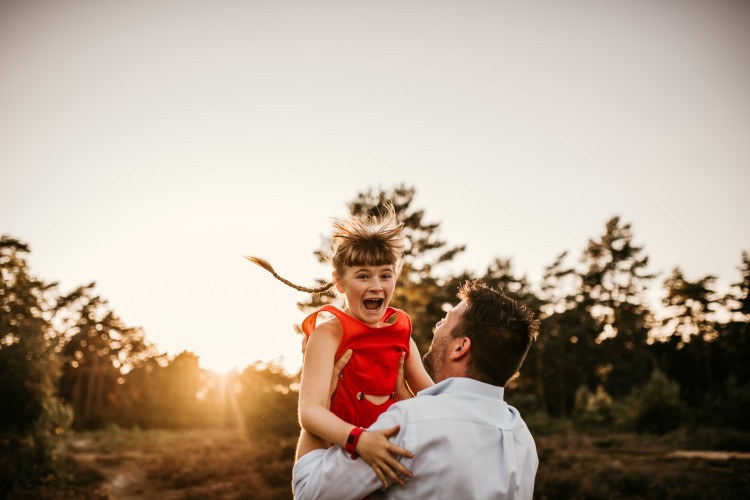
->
<box><xmin>300</xmin><ymin>186</ymin><xmax>750</xmax><ymax>433</ymax></box>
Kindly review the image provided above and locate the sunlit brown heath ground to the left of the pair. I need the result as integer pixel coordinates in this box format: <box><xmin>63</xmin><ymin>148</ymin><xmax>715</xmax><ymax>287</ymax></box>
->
<box><xmin>67</xmin><ymin>430</ymin><xmax>296</xmax><ymax>500</ymax></box>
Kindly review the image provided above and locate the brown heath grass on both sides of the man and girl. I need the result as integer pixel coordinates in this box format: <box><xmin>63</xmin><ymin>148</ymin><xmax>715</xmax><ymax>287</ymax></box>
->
<box><xmin>9</xmin><ymin>425</ymin><xmax>750</xmax><ymax>500</ymax></box>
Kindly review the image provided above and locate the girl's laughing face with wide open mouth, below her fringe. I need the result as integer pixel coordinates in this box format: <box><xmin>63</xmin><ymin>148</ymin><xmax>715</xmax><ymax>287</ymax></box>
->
<box><xmin>334</xmin><ymin>264</ymin><xmax>396</xmax><ymax>326</ymax></box>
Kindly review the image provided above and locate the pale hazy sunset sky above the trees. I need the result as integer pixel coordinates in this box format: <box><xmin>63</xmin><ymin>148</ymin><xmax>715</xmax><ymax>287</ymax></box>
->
<box><xmin>0</xmin><ymin>0</ymin><xmax>750</xmax><ymax>372</ymax></box>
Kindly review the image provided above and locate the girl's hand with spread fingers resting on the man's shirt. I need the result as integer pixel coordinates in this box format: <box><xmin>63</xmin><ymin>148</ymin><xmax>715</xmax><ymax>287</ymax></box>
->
<box><xmin>355</xmin><ymin>425</ymin><xmax>414</xmax><ymax>489</ymax></box>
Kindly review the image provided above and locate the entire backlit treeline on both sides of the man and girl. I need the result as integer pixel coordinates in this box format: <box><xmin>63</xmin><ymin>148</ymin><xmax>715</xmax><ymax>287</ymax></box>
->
<box><xmin>0</xmin><ymin>186</ymin><xmax>750</xmax><ymax>492</ymax></box>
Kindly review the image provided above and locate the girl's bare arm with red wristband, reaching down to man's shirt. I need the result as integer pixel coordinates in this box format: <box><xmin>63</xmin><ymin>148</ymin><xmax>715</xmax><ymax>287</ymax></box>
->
<box><xmin>299</xmin><ymin>321</ymin><xmax>412</xmax><ymax>487</ymax></box>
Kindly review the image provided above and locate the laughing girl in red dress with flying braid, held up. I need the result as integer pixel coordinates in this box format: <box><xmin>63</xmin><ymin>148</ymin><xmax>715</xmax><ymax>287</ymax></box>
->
<box><xmin>247</xmin><ymin>206</ymin><xmax>433</xmax><ymax>486</ymax></box>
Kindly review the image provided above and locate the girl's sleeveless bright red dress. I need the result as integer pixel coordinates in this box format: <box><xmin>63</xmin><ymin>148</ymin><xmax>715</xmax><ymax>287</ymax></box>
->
<box><xmin>302</xmin><ymin>305</ymin><xmax>411</xmax><ymax>427</ymax></box>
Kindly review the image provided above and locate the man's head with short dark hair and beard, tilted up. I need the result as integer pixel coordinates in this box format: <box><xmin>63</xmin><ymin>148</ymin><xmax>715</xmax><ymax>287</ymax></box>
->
<box><xmin>424</xmin><ymin>280</ymin><xmax>539</xmax><ymax>387</ymax></box>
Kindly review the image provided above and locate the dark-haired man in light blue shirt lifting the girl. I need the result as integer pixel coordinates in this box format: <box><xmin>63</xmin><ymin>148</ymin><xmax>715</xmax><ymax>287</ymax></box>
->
<box><xmin>293</xmin><ymin>281</ymin><xmax>539</xmax><ymax>500</ymax></box>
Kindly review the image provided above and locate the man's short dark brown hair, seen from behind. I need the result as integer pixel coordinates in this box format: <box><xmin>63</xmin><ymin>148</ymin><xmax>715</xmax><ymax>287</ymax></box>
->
<box><xmin>452</xmin><ymin>280</ymin><xmax>539</xmax><ymax>387</ymax></box>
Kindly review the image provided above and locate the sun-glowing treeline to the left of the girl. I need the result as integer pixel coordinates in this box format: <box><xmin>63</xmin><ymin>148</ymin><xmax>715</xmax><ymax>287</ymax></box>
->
<box><xmin>0</xmin><ymin>236</ymin><xmax>297</xmax><ymax>496</ymax></box>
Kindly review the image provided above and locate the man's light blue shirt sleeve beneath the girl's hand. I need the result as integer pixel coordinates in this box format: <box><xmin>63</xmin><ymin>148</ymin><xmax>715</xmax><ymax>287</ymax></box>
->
<box><xmin>292</xmin><ymin>404</ymin><xmax>411</xmax><ymax>500</ymax></box>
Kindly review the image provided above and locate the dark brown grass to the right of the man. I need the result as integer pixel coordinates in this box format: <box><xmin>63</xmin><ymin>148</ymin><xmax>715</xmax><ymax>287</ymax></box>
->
<box><xmin>535</xmin><ymin>431</ymin><xmax>750</xmax><ymax>500</ymax></box>
